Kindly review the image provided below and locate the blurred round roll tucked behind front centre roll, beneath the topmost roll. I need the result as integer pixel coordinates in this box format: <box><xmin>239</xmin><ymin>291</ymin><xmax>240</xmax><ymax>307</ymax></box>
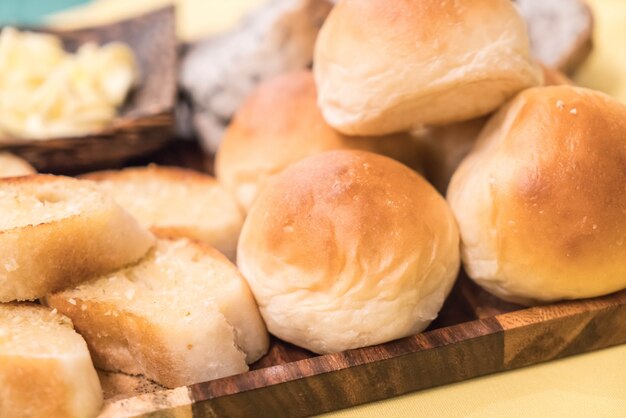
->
<box><xmin>216</xmin><ymin>70</ymin><xmax>421</xmax><ymax>210</ymax></box>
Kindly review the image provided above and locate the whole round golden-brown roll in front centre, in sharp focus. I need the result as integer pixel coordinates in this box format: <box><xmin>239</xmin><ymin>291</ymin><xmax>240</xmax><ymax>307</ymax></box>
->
<box><xmin>237</xmin><ymin>150</ymin><xmax>460</xmax><ymax>353</ymax></box>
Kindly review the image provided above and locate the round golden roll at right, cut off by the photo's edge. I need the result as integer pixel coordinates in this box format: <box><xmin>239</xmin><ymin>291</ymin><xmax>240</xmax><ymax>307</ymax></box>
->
<box><xmin>448</xmin><ymin>86</ymin><xmax>626</xmax><ymax>304</ymax></box>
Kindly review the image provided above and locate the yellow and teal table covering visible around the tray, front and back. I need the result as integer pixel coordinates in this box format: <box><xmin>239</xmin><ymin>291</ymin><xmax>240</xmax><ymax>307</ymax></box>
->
<box><xmin>0</xmin><ymin>0</ymin><xmax>626</xmax><ymax>418</ymax></box>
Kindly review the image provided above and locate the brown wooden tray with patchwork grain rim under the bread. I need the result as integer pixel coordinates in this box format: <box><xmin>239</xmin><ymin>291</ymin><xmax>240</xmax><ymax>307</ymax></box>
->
<box><xmin>88</xmin><ymin>143</ymin><xmax>626</xmax><ymax>417</ymax></box>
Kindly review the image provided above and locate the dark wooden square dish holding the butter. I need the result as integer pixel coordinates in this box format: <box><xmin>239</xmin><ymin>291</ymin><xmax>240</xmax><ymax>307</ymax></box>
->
<box><xmin>0</xmin><ymin>7</ymin><xmax>177</xmax><ymax>174</ymax></box>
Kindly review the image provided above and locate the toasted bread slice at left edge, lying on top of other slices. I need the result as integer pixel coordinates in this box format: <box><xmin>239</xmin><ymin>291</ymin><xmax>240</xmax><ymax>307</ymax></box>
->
<box><xmin>0</xmin><ymin>174</ymin><xmax>154</xmax><ymax>302</ymax></box>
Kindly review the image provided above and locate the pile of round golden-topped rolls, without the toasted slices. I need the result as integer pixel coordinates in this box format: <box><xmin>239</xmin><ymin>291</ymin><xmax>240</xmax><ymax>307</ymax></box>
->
<box><xmin>217</xmin><ymin>0</ymin><xmax>626</xmax><ymax>353</ymax></box>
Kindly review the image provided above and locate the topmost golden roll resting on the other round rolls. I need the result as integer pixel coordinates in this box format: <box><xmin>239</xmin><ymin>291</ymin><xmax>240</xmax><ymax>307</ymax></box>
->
<box><xmin>314</xmin><ymin>0</ymin><xmax>542</xmax><ymax>135</ymax></box>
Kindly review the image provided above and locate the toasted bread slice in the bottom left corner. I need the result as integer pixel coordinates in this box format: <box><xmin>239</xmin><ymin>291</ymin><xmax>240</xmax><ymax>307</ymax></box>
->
<box><xmin>0</xmin><ymin>303</ymin><xmax>102</xmax><ymax>418</ymax></box>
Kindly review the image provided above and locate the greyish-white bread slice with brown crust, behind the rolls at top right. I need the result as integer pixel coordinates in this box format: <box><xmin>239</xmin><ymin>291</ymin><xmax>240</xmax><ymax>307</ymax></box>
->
<box><xmin>515</xmin><ymin>0</ymin><xmax>593</xmax><ymax>74</ymax></box>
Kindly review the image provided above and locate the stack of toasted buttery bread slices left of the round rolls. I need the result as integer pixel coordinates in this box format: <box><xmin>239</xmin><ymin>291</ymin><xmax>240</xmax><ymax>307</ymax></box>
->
<box><xmin>0</xmin><ymin>164</ymin><xmax>269</xmax><ymax>417</ymax></box>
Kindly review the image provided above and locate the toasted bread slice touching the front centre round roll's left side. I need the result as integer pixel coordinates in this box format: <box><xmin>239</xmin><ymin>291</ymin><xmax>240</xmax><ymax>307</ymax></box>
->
<box><xmin>46</xmin><ymin>238</ymin><xmax>268</xmax><ymax>388</ymax></box>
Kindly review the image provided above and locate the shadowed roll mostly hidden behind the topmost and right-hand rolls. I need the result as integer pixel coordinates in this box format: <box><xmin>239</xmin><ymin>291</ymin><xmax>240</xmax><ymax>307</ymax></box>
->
<box><xmin>417</xmin><ymin>65</ymin><xmax>573</xmax><ymax>194</ymax></box>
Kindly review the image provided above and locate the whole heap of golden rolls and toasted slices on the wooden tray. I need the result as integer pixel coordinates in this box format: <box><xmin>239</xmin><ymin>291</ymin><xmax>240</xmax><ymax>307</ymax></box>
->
<box><xmin>0</xmin><ymin>0</ymin><xmax>626</xmax><ymax>417</ymax></box>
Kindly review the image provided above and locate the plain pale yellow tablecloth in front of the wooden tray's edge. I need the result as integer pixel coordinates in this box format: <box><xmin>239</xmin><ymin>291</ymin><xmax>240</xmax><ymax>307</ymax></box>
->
<box><xmin>324</xmin><ymin>345</ymin><xmax>626</xmax><ymax>418</ymax></box>
